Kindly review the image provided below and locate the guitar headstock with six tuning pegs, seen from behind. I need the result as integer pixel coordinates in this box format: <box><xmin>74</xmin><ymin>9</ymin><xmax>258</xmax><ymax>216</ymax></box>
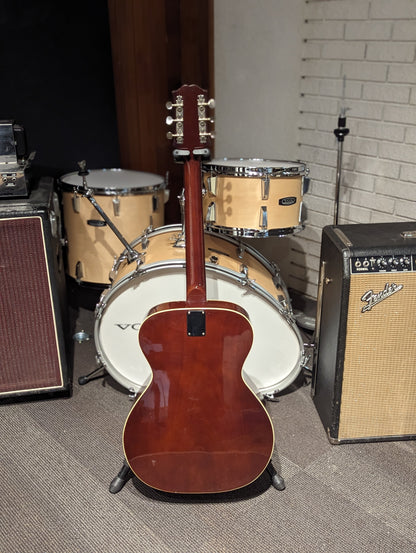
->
<box><xmin>166</xmin><ymin>84</ymin><xmax>215</xmax><ymax>157</ymax></box>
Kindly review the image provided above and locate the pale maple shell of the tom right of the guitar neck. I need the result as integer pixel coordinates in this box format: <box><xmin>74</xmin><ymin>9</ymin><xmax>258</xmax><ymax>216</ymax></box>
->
<box><xmin>203</xmin><ymin>173</ymin><xmax>302</xmax><ymax>233</ymax></box>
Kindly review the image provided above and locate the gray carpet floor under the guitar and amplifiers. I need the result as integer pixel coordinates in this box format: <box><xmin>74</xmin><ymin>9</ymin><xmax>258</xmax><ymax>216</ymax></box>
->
<box><xmin>0</xmin><ymin>309</ymin><xmax>416</xmax><ymax>553</ymax></box>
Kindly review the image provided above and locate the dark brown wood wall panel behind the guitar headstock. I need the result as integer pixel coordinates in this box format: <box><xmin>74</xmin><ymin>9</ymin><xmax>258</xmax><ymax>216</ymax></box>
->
<box><xmin>108</xmin><ymin>0</ymin><xmax>213</xmax><ymax>223</ymax></box>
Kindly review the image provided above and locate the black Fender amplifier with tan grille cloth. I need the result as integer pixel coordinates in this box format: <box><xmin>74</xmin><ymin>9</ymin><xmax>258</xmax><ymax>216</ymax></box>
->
<box><xmin>312</xmin><ymin>222</ymin><xmax>416</xmax><ymax>443</ymax></box>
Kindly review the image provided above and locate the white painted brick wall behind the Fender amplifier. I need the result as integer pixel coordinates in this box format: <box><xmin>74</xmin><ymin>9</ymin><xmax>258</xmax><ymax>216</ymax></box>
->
<box><xmin>286</xmin><ymin>0</ymin><xmax>416</xmax><ymax>297</ymax></box>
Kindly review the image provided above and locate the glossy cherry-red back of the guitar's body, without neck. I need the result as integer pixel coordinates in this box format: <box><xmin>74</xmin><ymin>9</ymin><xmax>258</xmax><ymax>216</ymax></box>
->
<box><xmin>124</xmin><ymin>302</ymin><xmax>274</xmax><ymax>493</ymax></box>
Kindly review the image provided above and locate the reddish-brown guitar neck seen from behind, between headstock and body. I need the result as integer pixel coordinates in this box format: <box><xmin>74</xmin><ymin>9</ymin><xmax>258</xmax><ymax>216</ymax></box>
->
<box><xmin>184</xmin><ymin>158</ymin><xmax>207</xmax><ymax>306</ymax></box>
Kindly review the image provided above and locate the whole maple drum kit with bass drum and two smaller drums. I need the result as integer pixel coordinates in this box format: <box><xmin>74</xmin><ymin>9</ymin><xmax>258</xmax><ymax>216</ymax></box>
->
<box><xmin>58</xmin><ymin>155</ymin><xmax>307</xmax><ymax>400</ymax></box>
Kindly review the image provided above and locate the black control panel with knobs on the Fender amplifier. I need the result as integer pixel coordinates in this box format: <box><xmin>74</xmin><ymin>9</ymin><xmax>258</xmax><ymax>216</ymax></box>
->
<box><xmin>350</xmin><ymin>252</ymin><xmax>416</xmax><ymax>274</ymax></box>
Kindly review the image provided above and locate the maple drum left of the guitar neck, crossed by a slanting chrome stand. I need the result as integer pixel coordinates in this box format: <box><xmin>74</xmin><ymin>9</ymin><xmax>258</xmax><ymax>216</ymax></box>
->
<box><xmin>59</xmin><ymin>169</ymin><xmax>167</xmax><ymax>285</ymax></box>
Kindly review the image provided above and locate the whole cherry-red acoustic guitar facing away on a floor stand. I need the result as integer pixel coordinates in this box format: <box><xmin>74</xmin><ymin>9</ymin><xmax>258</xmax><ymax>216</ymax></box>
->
<box><xmin>123</xmin><ymin>85</ymin><xmax>274</xmax><ymax>494</ymax></box>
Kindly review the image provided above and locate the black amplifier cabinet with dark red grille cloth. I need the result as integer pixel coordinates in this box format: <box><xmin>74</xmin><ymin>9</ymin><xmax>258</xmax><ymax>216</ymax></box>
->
<box><xmin>0</xmin><ymin>179</ymin><xmax>71</xmax><ymax>403</ymax></box>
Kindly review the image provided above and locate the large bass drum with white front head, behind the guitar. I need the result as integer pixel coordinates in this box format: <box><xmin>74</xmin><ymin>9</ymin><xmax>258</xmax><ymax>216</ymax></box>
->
<box><xmin>94</xmin><ymin>225</ymin><xmax>303</xmax><ymax>397</ymax></box>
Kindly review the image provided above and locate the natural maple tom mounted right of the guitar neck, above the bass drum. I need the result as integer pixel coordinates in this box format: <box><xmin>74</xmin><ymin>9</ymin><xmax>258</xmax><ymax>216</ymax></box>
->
<box><xmin>202</xmin><ymin>159</ymin><xmax>307</xmax><ymax>238</ymax></box>
